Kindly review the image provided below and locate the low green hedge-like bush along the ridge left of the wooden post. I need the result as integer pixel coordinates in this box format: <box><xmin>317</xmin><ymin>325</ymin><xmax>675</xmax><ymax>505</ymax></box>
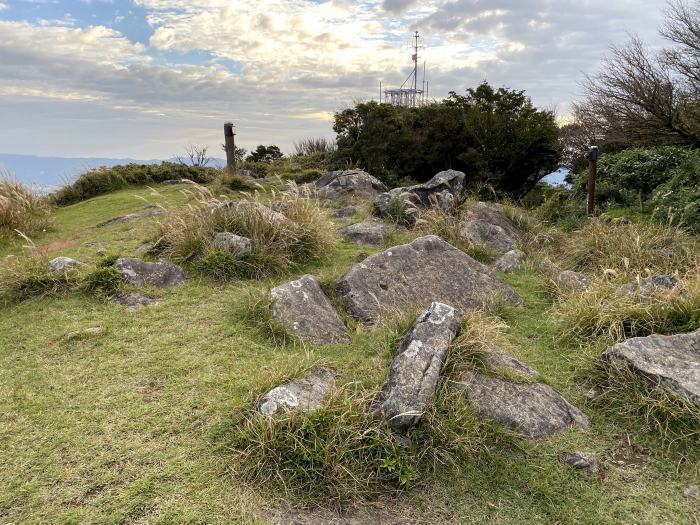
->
<box><xmin>51</xmin><ymin>162</ymin><xmax>218</xmax><ymax>206</ymax></box>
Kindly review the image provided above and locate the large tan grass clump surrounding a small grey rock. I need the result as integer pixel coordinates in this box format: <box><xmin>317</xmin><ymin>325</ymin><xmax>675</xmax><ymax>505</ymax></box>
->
<box><xmin>155</xmin><ymin>187</ymin><xmax>336</xmax><ymax>278</ymax></box>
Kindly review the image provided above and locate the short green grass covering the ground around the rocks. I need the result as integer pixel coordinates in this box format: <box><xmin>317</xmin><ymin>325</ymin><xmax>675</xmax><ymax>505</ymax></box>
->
<box><xmin>0</xmin><ymin>183</ymin><xmax>700</xmax><ymax>524</ymax></box>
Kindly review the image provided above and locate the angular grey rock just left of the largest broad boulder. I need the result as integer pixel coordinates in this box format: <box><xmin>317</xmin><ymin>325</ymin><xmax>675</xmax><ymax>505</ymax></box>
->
<box><xmin>270</xmin><ymin>275</ymin><xmax>350</xmax><ymax>344</ymax></box>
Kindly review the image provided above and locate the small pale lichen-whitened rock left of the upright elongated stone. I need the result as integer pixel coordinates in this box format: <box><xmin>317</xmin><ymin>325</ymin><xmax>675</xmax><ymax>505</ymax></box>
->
<box><xmin>258</xmin><ymin>367</ymin><xmax>335</xmax><ymax>416</ymax></box>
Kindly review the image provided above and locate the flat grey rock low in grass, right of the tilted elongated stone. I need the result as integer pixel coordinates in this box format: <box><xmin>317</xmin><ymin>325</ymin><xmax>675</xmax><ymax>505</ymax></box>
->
<box><xmin>456</xmin><ymin>371</ymin><xmax>589</xmax><ymax>438</ymax></box>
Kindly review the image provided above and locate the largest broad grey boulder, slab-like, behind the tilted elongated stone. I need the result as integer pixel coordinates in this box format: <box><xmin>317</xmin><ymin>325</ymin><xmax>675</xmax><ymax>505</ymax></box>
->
<box><xmin>337</xmin><ymin>235</ymin><xmax>522</xmax><ymax>323</ymax></box>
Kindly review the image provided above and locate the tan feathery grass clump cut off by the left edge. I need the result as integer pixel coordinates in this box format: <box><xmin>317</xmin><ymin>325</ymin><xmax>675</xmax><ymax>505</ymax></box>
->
<box><xmin>0</xmin><ymin>172</ymin><xmax>51</xmax><ymax>237</ymax></box>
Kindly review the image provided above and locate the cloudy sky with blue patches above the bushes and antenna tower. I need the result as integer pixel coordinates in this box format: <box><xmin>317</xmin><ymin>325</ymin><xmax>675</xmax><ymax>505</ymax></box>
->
<box><xmin>0</xmin><ymin>0</ymin><xmax>665</xmax><ymax>159</ymax></box>
